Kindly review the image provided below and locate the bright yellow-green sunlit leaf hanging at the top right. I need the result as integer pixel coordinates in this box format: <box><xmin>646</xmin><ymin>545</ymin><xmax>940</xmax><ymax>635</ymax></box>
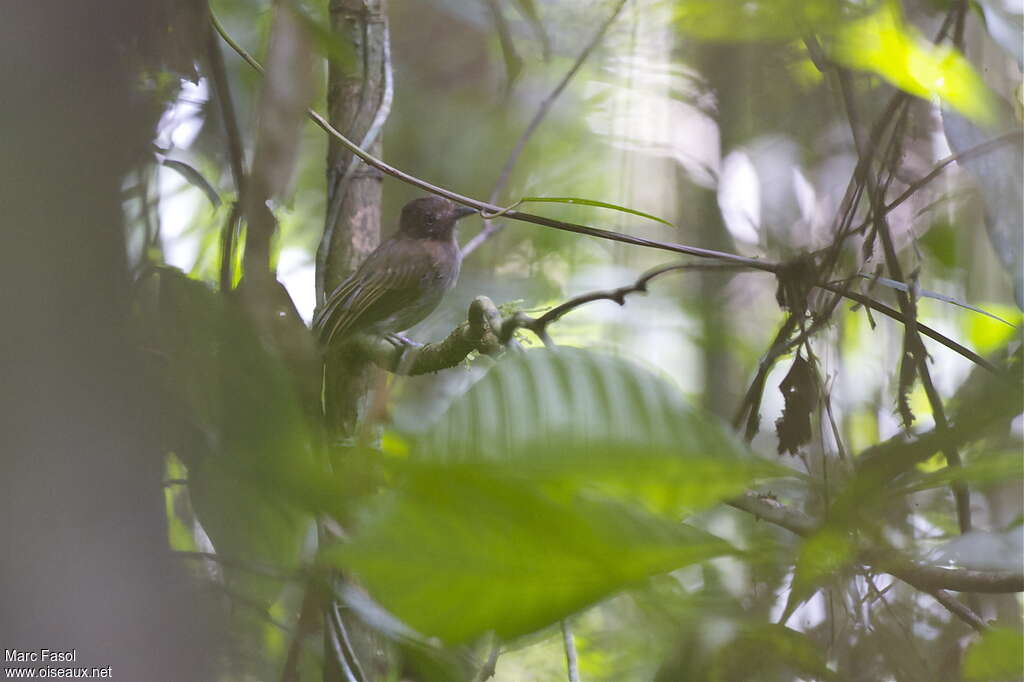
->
<box><xmin>833</xmin><ymin>1</ymin><xmax>993</xmax><ymax>124</ymax></box>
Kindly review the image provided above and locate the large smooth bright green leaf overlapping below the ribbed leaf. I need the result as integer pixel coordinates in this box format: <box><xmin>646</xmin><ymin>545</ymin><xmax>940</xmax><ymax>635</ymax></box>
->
<box><xmin>324</xmin><ymin>463</ymin><xmax>733</xmax><ymax>643</ymax></box>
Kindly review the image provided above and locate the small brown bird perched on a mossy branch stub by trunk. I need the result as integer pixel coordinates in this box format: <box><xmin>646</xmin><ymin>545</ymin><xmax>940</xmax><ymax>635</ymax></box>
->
<box><xmin>313</xmin><ymin>197</ymin><xmax>476</xmax><ymax>348</ymax></box>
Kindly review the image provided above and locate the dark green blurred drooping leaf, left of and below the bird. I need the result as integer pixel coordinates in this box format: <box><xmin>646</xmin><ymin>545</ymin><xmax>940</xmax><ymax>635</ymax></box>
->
<box><xmin>139</xmin><ymin>268</ymin><xmax>337</xmax><ymax>606</ymax></box>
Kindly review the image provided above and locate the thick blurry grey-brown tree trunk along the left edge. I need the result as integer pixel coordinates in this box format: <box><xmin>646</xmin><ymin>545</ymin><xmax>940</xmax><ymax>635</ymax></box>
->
<box><xmin>0</xmin><ymin>0</ymin><xmax>216</xmax><ymax>680</ymax></box>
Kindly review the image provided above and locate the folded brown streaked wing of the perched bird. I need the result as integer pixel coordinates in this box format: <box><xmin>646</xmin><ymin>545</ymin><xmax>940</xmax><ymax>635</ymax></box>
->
<box><xmin>312</xmin><ymin>239</ymin><xmax>430</xmax><ymax>345</ymax></box>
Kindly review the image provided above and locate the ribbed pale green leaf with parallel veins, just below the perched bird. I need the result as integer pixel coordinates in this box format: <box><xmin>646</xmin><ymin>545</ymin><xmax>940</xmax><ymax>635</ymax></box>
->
<box><xmin>415</xmin><ymin>347</ymin><xmax>792</xmax><ymax>517</ymax></box>
